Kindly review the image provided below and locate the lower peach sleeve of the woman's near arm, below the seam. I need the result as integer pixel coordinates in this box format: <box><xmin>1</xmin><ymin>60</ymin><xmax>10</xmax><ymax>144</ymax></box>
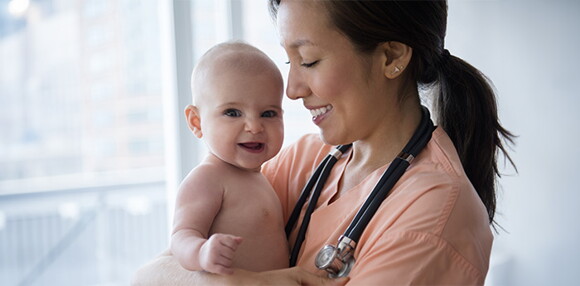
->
<box><xmin>348</xmin><ymin>232</ymin><xmax>485</xmax><ymax>285</ymax></box>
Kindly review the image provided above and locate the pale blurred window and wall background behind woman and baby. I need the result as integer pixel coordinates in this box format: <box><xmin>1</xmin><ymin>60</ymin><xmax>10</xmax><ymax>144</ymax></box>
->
<box><xmin>0</xmin><ymin>0</ymin><xmax>580</xmax><ymax>286</ymax></box>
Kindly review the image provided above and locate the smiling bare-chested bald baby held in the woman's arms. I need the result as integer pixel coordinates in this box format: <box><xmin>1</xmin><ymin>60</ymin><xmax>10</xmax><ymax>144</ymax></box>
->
<box><xmin>171</xmin><ymin>42</ymin><xmax>288</xmax><ymax>274</ymax></box>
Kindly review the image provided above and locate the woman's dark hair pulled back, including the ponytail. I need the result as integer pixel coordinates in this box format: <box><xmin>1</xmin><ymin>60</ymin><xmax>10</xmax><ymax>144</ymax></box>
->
<box><xmin>269</xmin><ymin>0</ymin><xmax>515</xmax><ymax>223</ymax></box>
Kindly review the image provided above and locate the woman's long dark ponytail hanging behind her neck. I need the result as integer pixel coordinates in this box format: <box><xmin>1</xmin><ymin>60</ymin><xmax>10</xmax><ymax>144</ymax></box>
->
<box><xmin>434</xmin><ymin>50</ymin><xmax>515</xmax><ymax>223</ymax></box>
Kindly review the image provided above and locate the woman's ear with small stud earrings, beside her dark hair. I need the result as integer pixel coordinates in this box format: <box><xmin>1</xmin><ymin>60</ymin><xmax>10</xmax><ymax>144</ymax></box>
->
<box><xmin>380</xmin><ymin>41</ymin><xmax>413</xmax><ymax>79</ymax></box>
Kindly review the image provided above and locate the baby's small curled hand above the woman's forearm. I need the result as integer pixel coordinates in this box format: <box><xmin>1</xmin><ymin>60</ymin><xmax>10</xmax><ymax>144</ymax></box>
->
<box><xmin>199</xmin><ymin>233</ymin><xmax>242</xmax><ymax>274</ymax></box>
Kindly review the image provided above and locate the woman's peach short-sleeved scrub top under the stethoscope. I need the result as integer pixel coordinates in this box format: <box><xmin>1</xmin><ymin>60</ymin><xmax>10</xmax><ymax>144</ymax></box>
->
<box><xmin>262</xmin><ymin>127</ymin><xmax>493</xmax><ymax>285</ymax></box>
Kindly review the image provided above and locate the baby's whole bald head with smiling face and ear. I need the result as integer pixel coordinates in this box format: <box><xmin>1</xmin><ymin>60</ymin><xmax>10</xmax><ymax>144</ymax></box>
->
<box><xmin>185</xmin><ymin>42</ymin><xmax>284</xmax><ymax>170</ymax></box>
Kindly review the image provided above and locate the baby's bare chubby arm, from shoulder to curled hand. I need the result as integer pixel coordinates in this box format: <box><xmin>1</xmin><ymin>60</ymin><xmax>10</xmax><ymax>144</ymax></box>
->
<box><xmin>171</xmin><ymin>165</ymin><xmax>242</xmax><ymax>274</ymax></box>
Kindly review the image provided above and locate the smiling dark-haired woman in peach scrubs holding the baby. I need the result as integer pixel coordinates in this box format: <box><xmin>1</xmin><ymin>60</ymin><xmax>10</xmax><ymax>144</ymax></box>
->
<box><xmin>131</xmin><ymin>0</ymin><xmax>513</xmax><ymax>285</ymax></box>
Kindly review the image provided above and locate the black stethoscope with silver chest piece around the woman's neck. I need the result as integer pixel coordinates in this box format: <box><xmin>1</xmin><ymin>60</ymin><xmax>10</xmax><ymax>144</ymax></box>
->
<box><xmin>286</xmin><ymin>106</ymin><xmax>435</xmax><ymax>278</ymax></box>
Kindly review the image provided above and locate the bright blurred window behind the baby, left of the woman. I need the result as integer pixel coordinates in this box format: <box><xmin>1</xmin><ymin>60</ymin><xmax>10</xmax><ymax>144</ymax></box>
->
<box><xmin>0</xmin><ymin>0</ymin><xmax>316</xmax><ymax>286</ymax></box>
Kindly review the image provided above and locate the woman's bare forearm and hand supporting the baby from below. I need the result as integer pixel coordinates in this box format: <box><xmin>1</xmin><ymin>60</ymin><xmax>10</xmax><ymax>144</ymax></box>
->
<box><xmin>131</xmin><ymin>250</ymin><xmax>348</xmax><ymax>286</ymax></box>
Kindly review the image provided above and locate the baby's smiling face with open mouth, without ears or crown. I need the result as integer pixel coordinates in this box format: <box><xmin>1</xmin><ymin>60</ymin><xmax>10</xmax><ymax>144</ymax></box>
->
<box><xmin>197</xmin><ymin>68</ymin><xmax>284</xmax><ymax>170</ymax></box>
